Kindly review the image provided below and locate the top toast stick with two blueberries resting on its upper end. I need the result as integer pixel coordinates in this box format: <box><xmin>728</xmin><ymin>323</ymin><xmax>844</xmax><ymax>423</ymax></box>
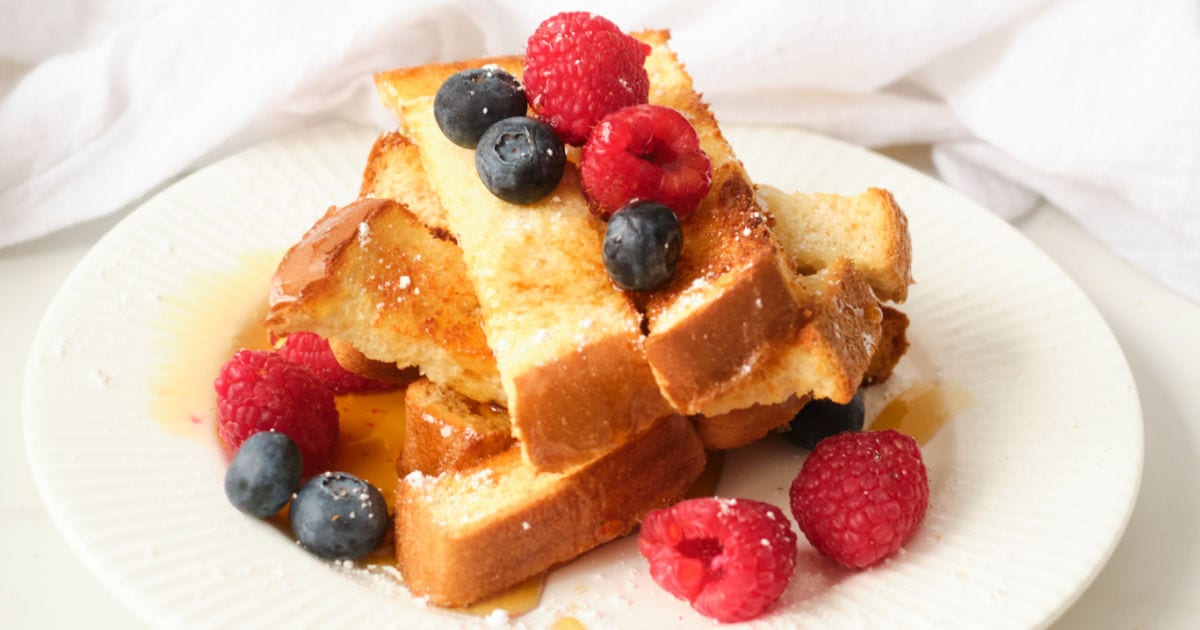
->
<box><xmin>376</xmin><ymin>49</ymin><xmax>672</xmax><ymax>470</ymax></box>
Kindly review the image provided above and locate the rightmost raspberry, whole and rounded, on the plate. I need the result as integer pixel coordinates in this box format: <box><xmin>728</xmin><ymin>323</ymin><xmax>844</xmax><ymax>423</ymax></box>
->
<box><xmin>790</xmin><ymin>430</ymin><xmax>929</xmax><ymax>569</ymax></box>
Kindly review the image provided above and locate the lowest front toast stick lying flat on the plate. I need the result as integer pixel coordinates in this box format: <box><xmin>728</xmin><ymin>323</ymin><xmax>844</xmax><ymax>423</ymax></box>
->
<box><xmin>395</xmin><ymin>416</ymin><xmax>706</xmax><ymax>606</ymax></box>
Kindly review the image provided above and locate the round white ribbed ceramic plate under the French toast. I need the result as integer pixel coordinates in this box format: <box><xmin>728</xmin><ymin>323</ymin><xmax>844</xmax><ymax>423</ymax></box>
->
<box><xmin>24</xmin><ymin>120</ymin><xmax>1142</xmax><ymax>629</ymax></box>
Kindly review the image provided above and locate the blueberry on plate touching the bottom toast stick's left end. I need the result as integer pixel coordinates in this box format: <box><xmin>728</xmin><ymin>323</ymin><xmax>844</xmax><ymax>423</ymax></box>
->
<box><xmin>288</xmin><ymin>473</ymin><xmax>388</xmax><ymax>560</ymax></box>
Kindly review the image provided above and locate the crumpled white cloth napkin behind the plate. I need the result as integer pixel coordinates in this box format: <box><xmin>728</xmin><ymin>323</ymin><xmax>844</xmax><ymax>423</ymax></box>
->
<box><xmin>0</xmin><ymin>0</ymin><xmax>1200</xmax><ymax>301</ymax></box>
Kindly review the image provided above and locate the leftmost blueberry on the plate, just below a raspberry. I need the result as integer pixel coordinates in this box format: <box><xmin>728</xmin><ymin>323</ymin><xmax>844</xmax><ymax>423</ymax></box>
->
<box><xmin>226</xmin><ymin>431</ymin><xmax>304</xmax><ymax>518</ymax></box>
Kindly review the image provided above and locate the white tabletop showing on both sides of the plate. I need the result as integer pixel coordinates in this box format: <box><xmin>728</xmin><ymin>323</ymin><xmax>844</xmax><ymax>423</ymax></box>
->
<box><xmin>0</xmin><ymin>142</ymin><xmax>1200</xmax><ymax>630</ymax></box>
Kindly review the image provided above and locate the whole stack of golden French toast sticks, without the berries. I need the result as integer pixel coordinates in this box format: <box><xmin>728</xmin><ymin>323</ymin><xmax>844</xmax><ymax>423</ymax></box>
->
<box><xmin>268</xmin><ymin>31</ymin><xmax>911</xmax><ymax>606</ymax></box>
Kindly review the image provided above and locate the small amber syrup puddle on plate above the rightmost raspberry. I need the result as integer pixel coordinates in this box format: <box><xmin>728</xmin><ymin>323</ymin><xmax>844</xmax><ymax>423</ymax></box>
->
<box><xmin>870</xmin><ymin>380</ymin><xmax>974</xmax><ymax>445</ymax></box>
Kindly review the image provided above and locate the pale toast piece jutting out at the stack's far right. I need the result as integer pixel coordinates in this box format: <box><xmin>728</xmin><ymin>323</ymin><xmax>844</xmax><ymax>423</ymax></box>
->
<box><xmin>757</xmin><ymin>185</ymin><xmax>912</xmax><ymax>302</ymax></box>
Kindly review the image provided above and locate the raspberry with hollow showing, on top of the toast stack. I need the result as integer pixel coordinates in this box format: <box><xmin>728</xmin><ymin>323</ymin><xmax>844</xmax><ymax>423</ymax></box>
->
<box><xmin>580</xmin><ymin>104</ymin><xmax>713</xmax><ymax>218</ymax></box>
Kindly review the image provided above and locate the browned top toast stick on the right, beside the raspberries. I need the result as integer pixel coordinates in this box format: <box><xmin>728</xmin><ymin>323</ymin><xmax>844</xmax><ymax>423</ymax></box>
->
<box><xmin>637</xmin><ymin>31</ymin><xmax>808</xmax><ymax>415</ymax></box>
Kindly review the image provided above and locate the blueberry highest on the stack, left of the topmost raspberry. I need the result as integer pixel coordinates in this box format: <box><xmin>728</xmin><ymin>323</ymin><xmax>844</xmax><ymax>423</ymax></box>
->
<box><xmin>433</xmin><ymin>66</ymin><xmax>528</xmax><ymax>149</ymax></box>
